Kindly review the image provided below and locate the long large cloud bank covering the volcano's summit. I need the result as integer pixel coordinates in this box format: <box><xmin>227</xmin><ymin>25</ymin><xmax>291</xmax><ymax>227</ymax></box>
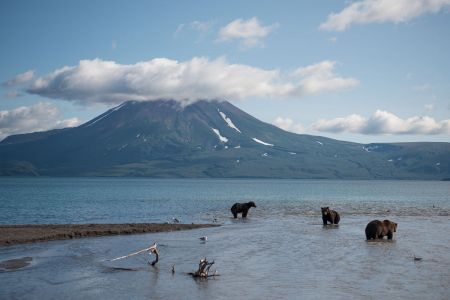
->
<box><xmin>27</xmin><ymin>57</ymin><xmax>358</xmax><ymax>104</ymax></box>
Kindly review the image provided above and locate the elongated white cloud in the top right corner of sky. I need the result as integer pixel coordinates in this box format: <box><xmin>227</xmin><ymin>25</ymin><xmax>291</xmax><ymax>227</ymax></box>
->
<box><xmin>319</xmin><ymin>0</ymin><xmax>450</xmax><ymax>31</ymax></box>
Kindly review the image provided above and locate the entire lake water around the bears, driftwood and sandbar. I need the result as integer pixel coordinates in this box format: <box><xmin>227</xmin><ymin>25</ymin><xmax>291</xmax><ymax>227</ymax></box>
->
<box><xmin>0</xmin><ymin>178</ymin><xmax>450</xmax><ymax>299</ymax></box>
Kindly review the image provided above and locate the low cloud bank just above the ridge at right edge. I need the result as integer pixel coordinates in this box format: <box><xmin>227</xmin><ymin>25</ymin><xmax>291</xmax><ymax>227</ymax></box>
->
<box><xmin>311</xmin><ymin>110</ymin><xmax>450</xmax><ymax>134</ymax></box>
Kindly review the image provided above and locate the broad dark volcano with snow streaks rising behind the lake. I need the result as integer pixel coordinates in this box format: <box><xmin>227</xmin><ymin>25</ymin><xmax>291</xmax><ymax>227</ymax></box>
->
<box><xmin>0</xmin><ymin>101</ymin><xmax>450</xmax><ymax>179</ymax></box>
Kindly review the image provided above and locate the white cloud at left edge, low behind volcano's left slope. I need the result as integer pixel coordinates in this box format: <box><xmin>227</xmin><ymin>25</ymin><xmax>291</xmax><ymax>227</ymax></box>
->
<box><xmin>0</xmin><ymin>102</ymin><xmax>80</xmax><ymax>140</ymax></box>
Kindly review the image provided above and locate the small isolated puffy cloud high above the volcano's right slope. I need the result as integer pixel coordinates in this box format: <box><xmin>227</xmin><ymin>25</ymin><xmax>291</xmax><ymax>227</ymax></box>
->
<box><xmin>217</xmin><ymin>17</ymin><xmax>279</xmax><ymax>50</ymax></box>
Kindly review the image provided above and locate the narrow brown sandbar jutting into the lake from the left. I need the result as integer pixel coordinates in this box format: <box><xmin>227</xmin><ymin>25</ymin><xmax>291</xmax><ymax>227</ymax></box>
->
<box><xmin>0</xmin><ymin>223</ymin><xmax>219</xmax><ymax>246</ymax></box>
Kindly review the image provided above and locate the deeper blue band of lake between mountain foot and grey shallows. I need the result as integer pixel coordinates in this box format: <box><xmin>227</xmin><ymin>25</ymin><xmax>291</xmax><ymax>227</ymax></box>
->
<box><xmin>0</xmin><ymin>178</ymin><xmax>450</xmax><ymax>224</ymax></box>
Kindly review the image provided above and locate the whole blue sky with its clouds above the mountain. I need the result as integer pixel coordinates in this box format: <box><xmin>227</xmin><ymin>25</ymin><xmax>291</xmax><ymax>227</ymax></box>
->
<box><xmin>0</xmin><ymin>0</ymin><xmax>450</xmax><ymax>143</ymax></box>
